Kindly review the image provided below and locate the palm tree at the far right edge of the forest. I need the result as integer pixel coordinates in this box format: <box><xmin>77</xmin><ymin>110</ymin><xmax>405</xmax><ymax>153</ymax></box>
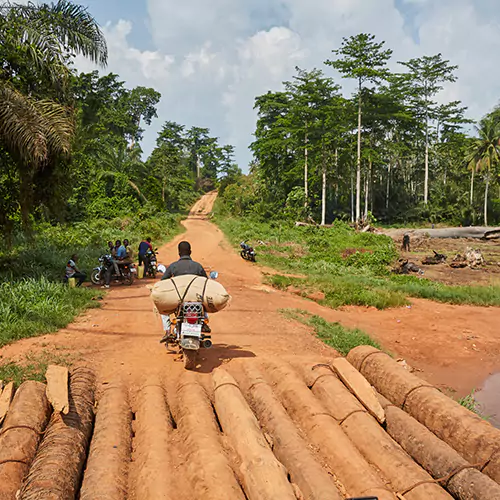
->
<box><xmin>467</xmin><ymin>116</ymin><xmax>500</xmax><ymax>226</ymax></box>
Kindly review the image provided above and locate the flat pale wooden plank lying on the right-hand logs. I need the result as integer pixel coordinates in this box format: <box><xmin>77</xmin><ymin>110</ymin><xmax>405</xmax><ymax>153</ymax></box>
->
<box><xmin>332</xmin><ymin>358</ymin><xmax>385</xmax><ymax>424</ymax></box>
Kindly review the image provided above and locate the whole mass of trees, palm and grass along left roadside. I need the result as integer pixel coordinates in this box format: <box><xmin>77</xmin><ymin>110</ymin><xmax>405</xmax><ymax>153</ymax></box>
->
<box><xmin>0</xmin><ymin>0</ymin><xmax>241</xmax><ymax>346</ymax></box>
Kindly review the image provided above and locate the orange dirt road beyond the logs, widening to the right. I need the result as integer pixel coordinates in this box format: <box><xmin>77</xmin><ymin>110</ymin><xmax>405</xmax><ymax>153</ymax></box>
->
<box><xmin>0</xmin><ymin>194</ymin><xmax>500</xmax><ymax>394</ymax></box>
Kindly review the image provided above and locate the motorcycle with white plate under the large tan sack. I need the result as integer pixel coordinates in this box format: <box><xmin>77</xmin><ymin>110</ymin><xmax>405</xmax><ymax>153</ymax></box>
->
<box><xmin>162</xmin><ymin>271</ymin><xmax>219</xmax><ymax>370</ymax></box>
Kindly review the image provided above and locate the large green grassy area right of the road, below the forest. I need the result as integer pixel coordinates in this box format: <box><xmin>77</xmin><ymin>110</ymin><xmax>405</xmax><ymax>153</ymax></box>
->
<box><xmin>216</xmin><ymin>216</ymin><xmax>500</xmax><ymax>309</ymax></box>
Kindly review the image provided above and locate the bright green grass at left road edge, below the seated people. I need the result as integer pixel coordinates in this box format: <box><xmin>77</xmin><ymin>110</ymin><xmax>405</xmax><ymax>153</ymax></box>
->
<box><xmin>0</xmin><ymin>278</ymin><xmax>101</xmax><ymax>347</ymax></box>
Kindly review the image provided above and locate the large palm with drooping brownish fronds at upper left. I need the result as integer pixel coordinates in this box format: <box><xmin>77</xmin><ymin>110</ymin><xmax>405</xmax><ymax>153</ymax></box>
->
<box><xmin>0</xmin><ymin>0</ymin><xmax>107</xmax><ymax>228</ymax></box>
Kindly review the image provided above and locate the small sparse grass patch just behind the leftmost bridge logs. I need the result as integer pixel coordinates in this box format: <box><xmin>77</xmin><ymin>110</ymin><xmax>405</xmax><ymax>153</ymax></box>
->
<box><xmin>0</xmin><ymin>352</ymin><xmax>73</xmax><ymax>387</ymax></box>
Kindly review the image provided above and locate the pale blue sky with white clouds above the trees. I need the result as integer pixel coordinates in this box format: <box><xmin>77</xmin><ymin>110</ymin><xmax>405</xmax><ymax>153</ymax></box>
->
<box><xmin>73</xmin><ymin>0</ymin><xmax>500</xmax><ymax>171</ymax></box>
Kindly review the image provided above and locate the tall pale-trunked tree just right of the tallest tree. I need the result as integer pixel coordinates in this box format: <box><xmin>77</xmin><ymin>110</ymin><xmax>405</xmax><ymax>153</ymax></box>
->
<box><xmin>400</xmin><ymin>54</ymin><xmax>457</xmax><ymax>205</ymax></box>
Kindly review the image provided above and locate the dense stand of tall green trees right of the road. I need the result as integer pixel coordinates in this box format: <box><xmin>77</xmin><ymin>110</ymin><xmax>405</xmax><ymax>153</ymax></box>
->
<box><xmin>222</xmin><ymin>34</ymin><xmax>500</xmax><ymax>229</ymax></box>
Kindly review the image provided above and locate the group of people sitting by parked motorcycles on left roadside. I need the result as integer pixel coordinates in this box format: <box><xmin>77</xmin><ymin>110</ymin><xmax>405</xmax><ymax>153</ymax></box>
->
<box><xmin>65</xmin><ymin>238</ymin><xmax>153</xmax><ymax>288</ymax></box>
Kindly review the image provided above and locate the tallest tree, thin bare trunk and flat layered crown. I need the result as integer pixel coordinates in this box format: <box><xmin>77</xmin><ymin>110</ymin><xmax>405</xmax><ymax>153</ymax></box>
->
<box><xmin>325</xmin><ymin>33</ymin><xmax>392</xmax><ymax>221</ymax></box>
